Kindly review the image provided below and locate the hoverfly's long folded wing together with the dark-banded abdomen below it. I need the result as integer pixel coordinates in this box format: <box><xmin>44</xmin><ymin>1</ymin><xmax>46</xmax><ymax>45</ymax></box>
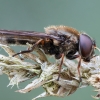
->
<box><xmin>0</xmin><ymin>30</ymin><xmax>61</xmax><ymax>45</ymax></box>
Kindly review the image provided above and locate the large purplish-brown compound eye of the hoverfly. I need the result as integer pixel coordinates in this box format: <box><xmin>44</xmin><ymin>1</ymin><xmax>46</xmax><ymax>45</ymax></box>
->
<box><xmin>79</xmin><ymin>34</ymin><xmax>93</xmax><ymax>58</ymax></box>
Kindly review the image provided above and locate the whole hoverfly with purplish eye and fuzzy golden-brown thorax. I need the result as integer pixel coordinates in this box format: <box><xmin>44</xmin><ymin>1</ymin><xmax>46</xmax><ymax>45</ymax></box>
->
<box><xmin>0</xmin><ymin>25</ymin><xmax>96</xmax><ymax>79</ymax></box>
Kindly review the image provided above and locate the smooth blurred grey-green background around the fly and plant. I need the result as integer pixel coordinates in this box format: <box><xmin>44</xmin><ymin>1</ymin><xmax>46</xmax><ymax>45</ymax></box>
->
<box><xmin>0</xmin><ymin>0</ymin><xmax>100</xmax><ymax>100</ymax></box>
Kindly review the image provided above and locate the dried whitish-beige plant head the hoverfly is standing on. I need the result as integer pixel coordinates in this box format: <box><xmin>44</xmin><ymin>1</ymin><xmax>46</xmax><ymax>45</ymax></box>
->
<box><xmin>0</xmin><ymin>44</ymin><xmax>100</xmax><ymax>100</ymax></box>
